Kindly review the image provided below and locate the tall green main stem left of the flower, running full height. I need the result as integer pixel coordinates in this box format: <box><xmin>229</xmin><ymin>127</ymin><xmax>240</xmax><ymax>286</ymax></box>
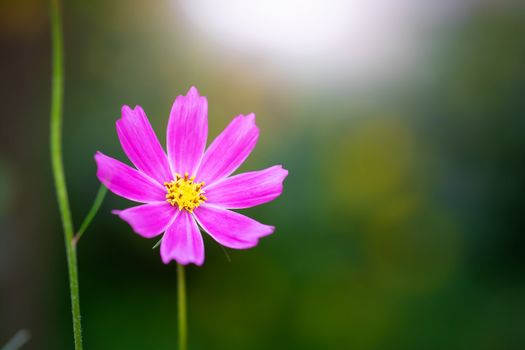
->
<box><xmin>50</xmin><ymin>0</ymin><xmax>82</xmax><ymax>350</ymax></box>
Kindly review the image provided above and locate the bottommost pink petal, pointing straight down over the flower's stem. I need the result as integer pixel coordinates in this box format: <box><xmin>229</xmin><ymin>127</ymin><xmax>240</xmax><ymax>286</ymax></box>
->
<box><xmin>160</xmin><ymin>210</ymin><xmax>204</xmax><ymax>266</ymax></box>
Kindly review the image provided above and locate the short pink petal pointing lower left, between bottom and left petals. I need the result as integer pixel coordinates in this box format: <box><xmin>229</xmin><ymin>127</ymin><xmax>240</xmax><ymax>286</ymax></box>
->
<box><xmin>113</xmin><ymin>202</ymin><xmax>174</xmax><ymax>238</ymax></box>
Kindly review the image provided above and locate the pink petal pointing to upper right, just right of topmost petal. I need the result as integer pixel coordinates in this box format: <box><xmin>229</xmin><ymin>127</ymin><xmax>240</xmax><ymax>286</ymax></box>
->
<box><xmin>197</xmin><ymin>114</ymin><xmax>259</xmax><ymax>185</ymax></box>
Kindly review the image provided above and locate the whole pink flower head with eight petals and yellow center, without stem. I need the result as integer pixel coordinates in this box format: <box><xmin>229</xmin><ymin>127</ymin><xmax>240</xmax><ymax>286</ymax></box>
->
<box><xmin>95</xmin><ymin>87</ymin><xmax>288</xmax><ymax>265</ymax></box>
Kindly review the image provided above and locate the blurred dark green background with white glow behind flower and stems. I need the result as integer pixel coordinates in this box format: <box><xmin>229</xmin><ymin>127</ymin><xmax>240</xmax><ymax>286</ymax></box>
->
<box><xmin>0</xmin><ymin>0</ymin><xmax>525</xmax><ymax>350</ymax></box>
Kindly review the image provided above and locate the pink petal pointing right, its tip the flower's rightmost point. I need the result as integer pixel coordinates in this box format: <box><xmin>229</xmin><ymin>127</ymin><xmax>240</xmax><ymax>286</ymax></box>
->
<box><xmin>204</xmin><ymin>165</ymin><xmax>288</xmax><ymax>209</ymax></box>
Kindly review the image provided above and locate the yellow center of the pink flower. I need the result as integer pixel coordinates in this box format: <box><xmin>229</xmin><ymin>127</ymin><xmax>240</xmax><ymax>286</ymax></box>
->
<box><xmin>164</xmin><ymin>173</ymin><xmax>207</xmax><ymax>213</ymax></box>
